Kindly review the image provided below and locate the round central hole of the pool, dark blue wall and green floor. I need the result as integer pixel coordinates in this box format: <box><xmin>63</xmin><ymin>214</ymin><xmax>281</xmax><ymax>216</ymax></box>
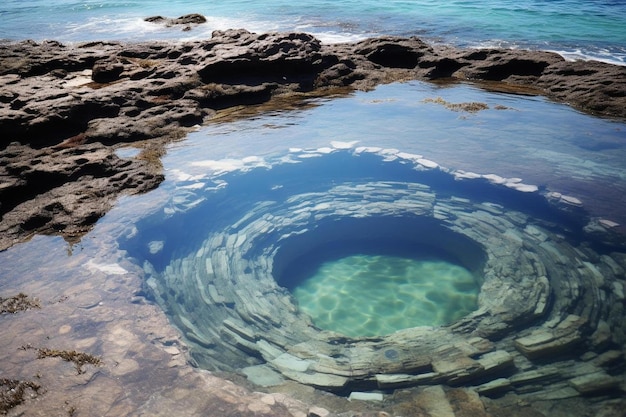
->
<box><xmin>272</xmin><ymin>213</ymin><xmax>485</xmax><ymax>337</ymax></box>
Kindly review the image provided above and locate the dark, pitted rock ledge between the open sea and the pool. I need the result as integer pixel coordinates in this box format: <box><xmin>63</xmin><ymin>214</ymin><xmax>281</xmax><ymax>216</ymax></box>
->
<box><xmin>0</xmin><ymin>30</ymin><xmax>626</xmax><ymax>250</ymax></box>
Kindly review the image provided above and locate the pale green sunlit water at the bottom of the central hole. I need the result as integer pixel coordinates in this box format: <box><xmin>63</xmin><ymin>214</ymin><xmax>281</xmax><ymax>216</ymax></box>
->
<box><xmin>292</xmin><ymin>255</ymin><xmax>478</xmax><ymax>337</ymax></box>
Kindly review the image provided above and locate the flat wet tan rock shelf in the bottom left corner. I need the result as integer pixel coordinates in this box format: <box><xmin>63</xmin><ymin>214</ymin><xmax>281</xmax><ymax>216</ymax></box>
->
<box><xmin>0</xmin><ymin>237</ymin><xmax>326</xmax><ymax>417</ymax></box>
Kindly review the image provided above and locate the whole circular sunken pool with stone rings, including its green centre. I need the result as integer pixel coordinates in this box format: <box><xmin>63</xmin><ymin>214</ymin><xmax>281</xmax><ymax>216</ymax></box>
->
<box><xmin>121</xmin><ymin>147</ymin><xmax>617</xmax><ymax>393</ymax></box>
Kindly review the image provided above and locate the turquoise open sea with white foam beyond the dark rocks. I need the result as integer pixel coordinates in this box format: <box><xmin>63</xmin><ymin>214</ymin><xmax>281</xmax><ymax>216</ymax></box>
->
<box><xmin>0</xmin><ymin>0</ymin><xmax>626</xmax><ymax>65</ymax></box>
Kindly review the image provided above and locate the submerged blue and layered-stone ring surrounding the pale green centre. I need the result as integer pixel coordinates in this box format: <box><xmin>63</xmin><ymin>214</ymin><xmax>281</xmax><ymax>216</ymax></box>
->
<box><xmin>123</xmin><ymin>142</ymin><xmax>625</xmax><ymax>396</ymax></box>
